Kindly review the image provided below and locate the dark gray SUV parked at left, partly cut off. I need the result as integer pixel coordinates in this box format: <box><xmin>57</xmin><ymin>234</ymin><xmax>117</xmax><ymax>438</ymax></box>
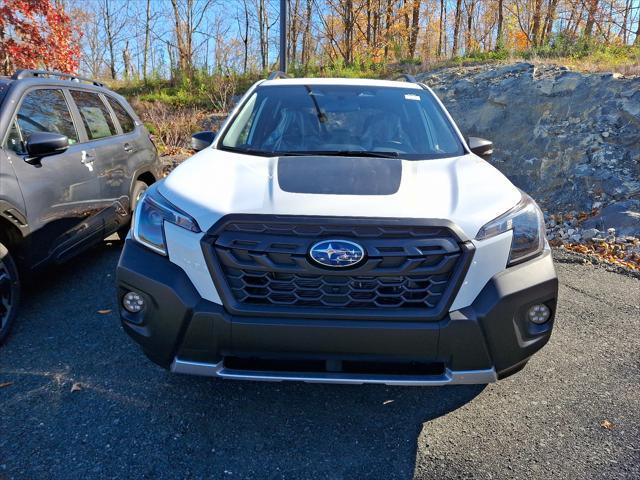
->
<box><xmin>0</xmin><ymin>70</ymin><xmax>161</xmax><ymax>343</ymax></box>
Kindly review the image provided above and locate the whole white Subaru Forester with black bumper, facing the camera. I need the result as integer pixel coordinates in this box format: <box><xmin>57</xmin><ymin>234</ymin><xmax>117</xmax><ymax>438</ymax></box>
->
<box><xmin>117</xmin><ymin>75</ymin><xmax>558</xmax><ymax>385</ymax></box>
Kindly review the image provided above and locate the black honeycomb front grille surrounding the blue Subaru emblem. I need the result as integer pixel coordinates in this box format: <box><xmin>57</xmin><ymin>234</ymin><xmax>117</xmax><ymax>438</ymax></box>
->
<box><xmin>203</xmin><ymin>216</ymin><xmax>471</xmax><ymax>320</ymax></box>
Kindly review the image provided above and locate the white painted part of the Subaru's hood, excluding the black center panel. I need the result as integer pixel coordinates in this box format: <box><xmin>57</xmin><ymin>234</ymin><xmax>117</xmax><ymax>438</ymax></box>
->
<box><xmin>159</xmin><ymin>149</ymin><xmax>521</xmax><ymax>238</ymax></box>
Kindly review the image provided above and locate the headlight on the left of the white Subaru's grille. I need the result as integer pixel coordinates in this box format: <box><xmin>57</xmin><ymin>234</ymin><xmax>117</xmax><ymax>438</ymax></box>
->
<box><xmin>133</xmin><ymin>187</ymin><xmax>200</xmax><ymax>255</ymax></box>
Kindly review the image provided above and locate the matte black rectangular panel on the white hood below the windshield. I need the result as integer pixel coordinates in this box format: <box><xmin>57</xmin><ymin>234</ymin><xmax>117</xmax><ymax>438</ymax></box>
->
<box><xmin>277</xmin><ymin>156</ymin><xmax>402</xmax><ymax>195</ymax></box>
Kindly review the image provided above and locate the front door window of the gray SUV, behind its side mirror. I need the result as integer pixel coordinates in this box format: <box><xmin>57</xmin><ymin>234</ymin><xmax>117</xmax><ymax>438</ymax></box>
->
<box><xmin>14</xmin><ymin>89</ymin><xmax>78</xmax><ymax>144</ymax></box>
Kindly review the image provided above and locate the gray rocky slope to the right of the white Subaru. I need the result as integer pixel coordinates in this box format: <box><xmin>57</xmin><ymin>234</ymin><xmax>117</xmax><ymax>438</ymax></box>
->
<box><xmin>417</xmin><ymin>63</ymin><xmax>640</xmax><ymax>235</ymax></box>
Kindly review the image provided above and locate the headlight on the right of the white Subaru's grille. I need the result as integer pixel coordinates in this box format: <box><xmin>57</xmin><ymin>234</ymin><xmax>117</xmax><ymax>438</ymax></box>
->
<box><xmin>476</xmin><ymin>193</ymin><xmax>545</xmax><ymax>266</ymax></box>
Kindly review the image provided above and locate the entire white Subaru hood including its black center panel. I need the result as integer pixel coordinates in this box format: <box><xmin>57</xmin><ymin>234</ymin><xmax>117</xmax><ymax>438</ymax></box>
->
<box><xmin>159</xmin><ymin>148</ymin><xmax>521</xmax><ymax>238</ymax></box>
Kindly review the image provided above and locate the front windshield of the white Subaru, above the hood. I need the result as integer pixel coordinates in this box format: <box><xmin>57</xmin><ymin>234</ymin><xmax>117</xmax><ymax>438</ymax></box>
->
<box><xmin>219</xmin><ymin>85</ymin><xmax>464</xmax><ymax>159</ymax></box>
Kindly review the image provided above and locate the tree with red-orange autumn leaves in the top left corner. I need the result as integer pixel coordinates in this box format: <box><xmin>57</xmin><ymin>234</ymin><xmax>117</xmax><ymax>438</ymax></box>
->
<box><xmin>0</xmin><ymin>0</ymin><xmax>81</xmax><ymax>75</ymax></box>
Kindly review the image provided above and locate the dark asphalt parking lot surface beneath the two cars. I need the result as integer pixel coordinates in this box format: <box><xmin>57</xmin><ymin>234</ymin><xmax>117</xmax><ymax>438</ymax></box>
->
<box><xmin>0</xmin><ymin>242</ymin><xmax>640</xmax><ymax>480</ymax></box>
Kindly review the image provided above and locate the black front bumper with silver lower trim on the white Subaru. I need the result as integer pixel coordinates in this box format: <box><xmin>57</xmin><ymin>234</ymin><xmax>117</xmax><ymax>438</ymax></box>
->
<box><xmin>117</xmin><ymin>239</ymin><xmax>558</xmax><ymax>385</ymax></box>
